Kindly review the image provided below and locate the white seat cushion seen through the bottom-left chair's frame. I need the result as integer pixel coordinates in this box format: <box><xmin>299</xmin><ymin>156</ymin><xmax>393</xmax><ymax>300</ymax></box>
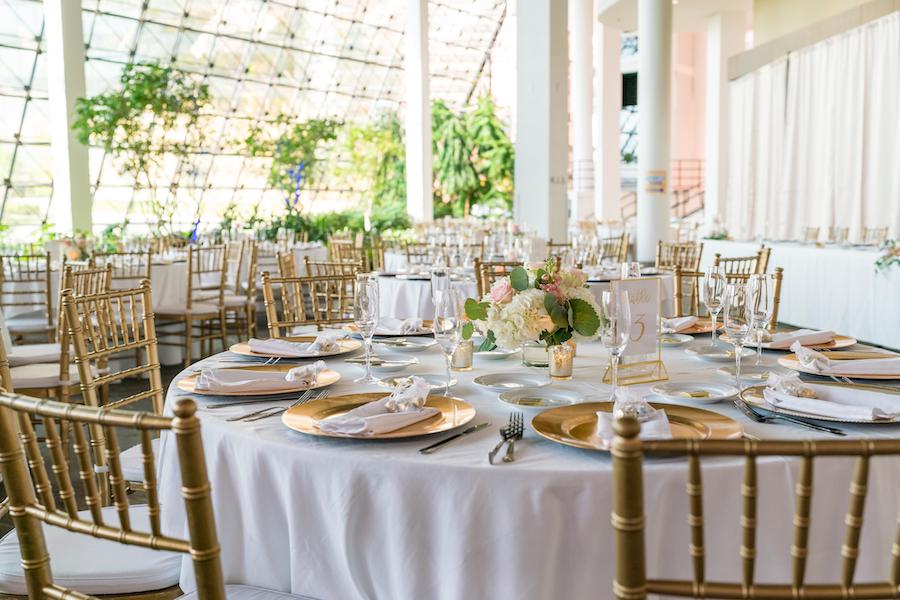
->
<box><xmin>0</xmin><ymin>505</ymin><xmax>182</xmax><ymax>594</ymax></box>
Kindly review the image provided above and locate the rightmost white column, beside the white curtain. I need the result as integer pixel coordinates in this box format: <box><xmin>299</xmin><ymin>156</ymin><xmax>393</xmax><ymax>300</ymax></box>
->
<box><xmin>704</xmin><ymin>11</ymin><xmax>745</xmax><ymax>232</ymax></box>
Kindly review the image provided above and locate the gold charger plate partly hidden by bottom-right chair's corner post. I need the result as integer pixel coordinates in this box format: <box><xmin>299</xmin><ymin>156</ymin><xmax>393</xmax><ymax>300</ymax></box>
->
<box><xmin>531</xmin><ymin>402</ymin><xmax>744</xmax><ymax>452</ymax></box>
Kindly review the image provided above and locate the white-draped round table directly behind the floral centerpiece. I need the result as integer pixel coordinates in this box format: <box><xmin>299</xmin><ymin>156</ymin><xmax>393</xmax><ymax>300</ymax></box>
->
<box><xmin>378</xmin><ymin>274</ymin><xmax>675</xmax><ymax>319</ymax></box>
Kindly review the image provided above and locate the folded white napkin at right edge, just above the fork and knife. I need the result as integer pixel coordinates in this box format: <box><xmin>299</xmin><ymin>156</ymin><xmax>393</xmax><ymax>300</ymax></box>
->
<box><xmin>763</xmin><ymin>375</ymin><xmax>900</xmax><ymax>421</ymax></box>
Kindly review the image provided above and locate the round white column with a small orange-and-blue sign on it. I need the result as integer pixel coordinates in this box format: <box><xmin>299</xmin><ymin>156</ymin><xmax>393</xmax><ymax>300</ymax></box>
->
<box><xmin>637</xmin><ymin>0</ymin><xmax>672</xmax><ymax>262</ymax></box>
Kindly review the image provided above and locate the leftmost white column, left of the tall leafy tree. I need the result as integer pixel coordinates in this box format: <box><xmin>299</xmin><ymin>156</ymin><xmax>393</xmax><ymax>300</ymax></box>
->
<box><xmin>44</xmin><ymin>0</ymin><xmax>92</xmax><ymax>232</ymax></box>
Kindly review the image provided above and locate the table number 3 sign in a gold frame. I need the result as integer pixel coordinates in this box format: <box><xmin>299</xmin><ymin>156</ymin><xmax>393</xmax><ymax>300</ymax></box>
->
<box><xmin>603</xmin><ymin>277</ymin><xmax>669</xmax><ymax>385</ymax></box>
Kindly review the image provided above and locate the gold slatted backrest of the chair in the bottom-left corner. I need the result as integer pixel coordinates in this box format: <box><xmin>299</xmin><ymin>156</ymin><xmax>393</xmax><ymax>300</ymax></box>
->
<box><xmin>0</xmin><ymin>393</ymin><xmax>225</xmax><ymax>600</ymax></box>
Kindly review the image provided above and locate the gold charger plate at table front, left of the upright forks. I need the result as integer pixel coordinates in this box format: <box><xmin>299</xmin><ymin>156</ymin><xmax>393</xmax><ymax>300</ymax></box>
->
<box><xmin>281</xmin><ymin>392</ymin><xmax>475</xmax><ymax>440</ymax></box>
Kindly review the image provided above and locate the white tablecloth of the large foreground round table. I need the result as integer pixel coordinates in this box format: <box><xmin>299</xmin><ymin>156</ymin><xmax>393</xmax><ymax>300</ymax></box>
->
<box><xmin>159</xmin><ymin>343</ymin><xmax>900</xmax><ymax>600</ymax></box>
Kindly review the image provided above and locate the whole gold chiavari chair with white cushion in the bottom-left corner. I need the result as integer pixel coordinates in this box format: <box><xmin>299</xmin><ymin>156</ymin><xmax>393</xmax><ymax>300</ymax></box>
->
<box><xmin>0</xmin><ymin>393</ymin><xmax>227</xmax><ymax>600</ymax></box>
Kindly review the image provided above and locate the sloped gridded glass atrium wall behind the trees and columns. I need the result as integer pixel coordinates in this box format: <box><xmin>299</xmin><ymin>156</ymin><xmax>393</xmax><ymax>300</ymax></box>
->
<box><xmin>0</xmin><ymin>0</ymin><xmax>506</xmax><ymax>231</ymax></box>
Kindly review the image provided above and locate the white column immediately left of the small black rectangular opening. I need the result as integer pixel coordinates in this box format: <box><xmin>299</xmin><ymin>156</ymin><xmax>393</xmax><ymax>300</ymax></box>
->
<box><xmin>594</xmin><ymin>22</ymin><xmax>622</xmax><ymax>221</ymax></box>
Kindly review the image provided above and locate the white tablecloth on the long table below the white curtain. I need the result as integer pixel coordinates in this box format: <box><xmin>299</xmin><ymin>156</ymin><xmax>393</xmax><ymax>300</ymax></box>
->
<box><xmin>702</xmin><ymin>240</ymin><xmax>900</xmax><ymax>349</ymax></box>
